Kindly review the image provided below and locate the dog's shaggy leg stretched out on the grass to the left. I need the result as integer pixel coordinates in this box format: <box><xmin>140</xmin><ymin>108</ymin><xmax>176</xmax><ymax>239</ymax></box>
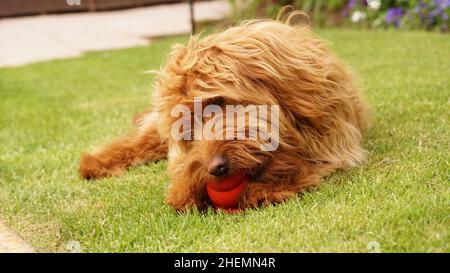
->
<box><xmin>80</xmin><ymin>116</ymin><xmax>167</xmax><ymax>179</ymax></box>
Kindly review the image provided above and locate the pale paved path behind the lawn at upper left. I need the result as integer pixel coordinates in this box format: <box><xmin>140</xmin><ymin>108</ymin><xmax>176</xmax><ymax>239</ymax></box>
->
<box><xmin>0</xmin><ymin>0</ymin><xmax>230</xmax><ymax>67</ymax></box>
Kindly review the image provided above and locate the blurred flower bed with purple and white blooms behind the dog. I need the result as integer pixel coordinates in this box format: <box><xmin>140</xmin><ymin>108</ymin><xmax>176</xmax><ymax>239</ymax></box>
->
<box><xmin>230</xmin><ymin>0</ymin><xmax>450</xmax><ymax>32</ymax></box>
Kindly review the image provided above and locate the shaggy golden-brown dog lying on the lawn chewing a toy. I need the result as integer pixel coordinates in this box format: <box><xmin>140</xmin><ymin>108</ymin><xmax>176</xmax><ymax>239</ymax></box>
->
<box><xmin>80</xmin><ymin>12</ymin><xmax>367</xmax><ymax>211</ymax></box>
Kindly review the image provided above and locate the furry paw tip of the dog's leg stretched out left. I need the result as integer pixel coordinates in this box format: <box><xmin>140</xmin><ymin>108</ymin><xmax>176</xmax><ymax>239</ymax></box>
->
<box><xmin>79</xmin><ymin>154</ymin><xmax>121</xmax><ymax>180</ymax></box>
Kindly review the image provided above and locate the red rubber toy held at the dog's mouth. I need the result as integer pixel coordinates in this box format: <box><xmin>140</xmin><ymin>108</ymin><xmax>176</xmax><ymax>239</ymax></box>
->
<box><xmin>206</xmin><ymin>170</ymin><xmax>248</xmax><ymax>213</ymax></box>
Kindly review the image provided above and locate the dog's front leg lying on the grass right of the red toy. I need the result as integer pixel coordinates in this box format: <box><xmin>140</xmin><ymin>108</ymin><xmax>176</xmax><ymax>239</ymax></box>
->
<box><xmin>239</xmin><ymin>165</ymin><xmax>335</xmax><ymax>208</ymax></box>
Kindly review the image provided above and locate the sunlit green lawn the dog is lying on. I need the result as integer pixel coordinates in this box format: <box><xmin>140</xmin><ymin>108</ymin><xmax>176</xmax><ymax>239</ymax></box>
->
<box><xmin>0</xmin><ymin>30</ymin><xmax>450</xmax><ymax>252</ymax></box>
